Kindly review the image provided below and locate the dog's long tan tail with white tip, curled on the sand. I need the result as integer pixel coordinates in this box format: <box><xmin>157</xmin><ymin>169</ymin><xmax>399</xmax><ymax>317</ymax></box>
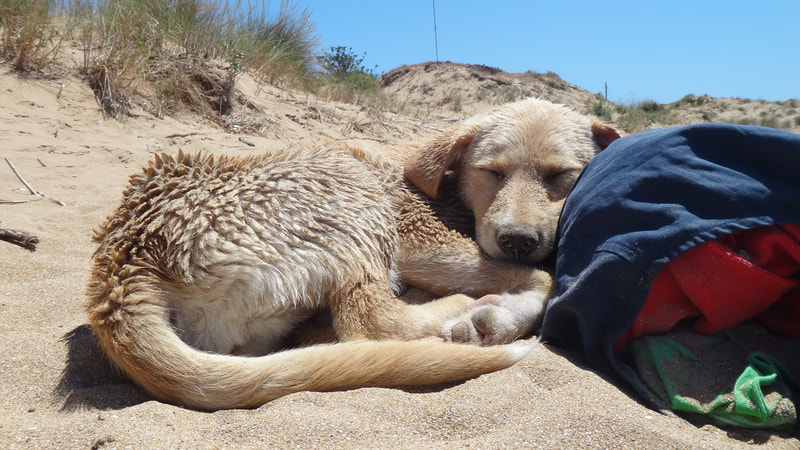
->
<box><xmin>90</xmin><ymin>293</ymin><xmax>535</xmax><ymax>410</ymax></box>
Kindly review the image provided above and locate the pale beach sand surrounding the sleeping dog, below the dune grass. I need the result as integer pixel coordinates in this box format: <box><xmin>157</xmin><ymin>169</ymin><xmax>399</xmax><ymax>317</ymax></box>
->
<box><xmin>0</xmin><ymin>65</ymin><xmax>800</xmax><ymax>449</ymax></box>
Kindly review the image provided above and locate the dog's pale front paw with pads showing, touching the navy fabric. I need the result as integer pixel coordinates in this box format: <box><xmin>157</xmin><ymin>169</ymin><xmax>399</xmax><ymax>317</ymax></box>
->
<box><xmin>442</xmin><ymin>291</ymin><xmax>547</xmax><ymax>345</ymax></box>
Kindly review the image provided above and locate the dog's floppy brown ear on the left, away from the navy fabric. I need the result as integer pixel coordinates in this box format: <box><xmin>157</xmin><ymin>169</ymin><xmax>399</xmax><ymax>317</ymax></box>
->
<box><xmin>404</xmin><ymin>124</ymin><xmax>478</xmax><ymax>198</ymax></box>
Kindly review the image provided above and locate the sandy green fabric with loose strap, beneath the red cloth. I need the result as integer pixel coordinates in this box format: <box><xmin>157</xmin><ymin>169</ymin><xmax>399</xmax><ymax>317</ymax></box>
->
<box><xmin>630</xmin><ymin>327</ymin><xmax>800</xmax><ymax>429</ymax></box>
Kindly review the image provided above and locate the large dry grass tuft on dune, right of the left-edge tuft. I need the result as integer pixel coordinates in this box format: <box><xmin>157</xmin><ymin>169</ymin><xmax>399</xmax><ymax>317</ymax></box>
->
<box><xmin>77</xmin><ymin>0</ymin><xmax>317</xmax><ymax>119</ymax></box>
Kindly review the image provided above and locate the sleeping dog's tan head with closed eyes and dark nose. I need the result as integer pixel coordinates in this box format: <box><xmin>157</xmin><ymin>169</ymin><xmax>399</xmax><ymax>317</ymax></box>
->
<box><xmin>405</xmin><ymin>99</ymin><xmax>620</xmax><ymax>263</ymax></box>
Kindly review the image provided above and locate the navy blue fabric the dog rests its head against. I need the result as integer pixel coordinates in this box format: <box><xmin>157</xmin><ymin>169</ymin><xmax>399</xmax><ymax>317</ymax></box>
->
<box><xmin>541</xmin><ymin>124</ymin><xmax>800</xmax><ymax>398</ymax></box>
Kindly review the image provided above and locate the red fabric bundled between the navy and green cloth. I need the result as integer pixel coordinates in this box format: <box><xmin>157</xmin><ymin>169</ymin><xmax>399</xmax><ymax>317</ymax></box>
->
<box><xmin>614</xmin><ymin>225</ymin><xmax>800</xmax><ymax>352</ymax></box>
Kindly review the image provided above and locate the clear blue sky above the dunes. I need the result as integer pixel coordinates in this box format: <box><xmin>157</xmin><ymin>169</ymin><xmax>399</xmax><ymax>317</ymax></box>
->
<box><xmin>292</xmin><ymin>0</ymin><xmax>800</xmax><ymax>103</ymax></box>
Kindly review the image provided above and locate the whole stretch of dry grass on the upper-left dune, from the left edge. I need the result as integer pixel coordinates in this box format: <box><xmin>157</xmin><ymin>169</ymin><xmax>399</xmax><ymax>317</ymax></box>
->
<box><xmin>0</xmin><ymin>0</ymin><xmax>328</xmax><ymax>117</ymax></box>
